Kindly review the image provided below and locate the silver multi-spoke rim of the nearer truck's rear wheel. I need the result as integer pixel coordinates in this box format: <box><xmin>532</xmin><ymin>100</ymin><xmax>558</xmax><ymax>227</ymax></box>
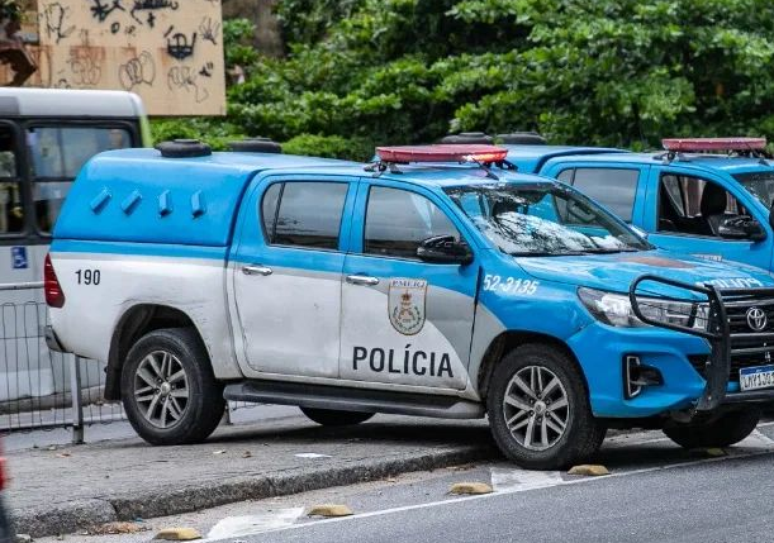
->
<box><xmin>134</xmin><ymin>351</ymin><xmax>189</xmax><ymax>430</ymax></box>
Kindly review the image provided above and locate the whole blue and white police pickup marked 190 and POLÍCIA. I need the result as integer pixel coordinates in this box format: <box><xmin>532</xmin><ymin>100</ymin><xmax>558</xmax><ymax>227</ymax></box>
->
<box><xmin>45</xmin><ymin>142</ymin><xmax>774</xmax><ymax>468</ymax></box>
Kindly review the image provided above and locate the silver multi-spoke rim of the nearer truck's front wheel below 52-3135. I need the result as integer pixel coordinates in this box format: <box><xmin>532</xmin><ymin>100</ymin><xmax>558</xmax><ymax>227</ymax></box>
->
<box><xmin>503</xmin><ymin>366</ymin><xmax>570</xmax><ymax>451</ymax></box>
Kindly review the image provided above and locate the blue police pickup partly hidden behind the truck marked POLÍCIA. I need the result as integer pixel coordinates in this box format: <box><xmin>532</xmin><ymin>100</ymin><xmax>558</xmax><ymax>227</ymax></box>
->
<box><xmin>508</xmin><ymin>138</ymin><xmax>774</xmax><ymax>280</ymax></box>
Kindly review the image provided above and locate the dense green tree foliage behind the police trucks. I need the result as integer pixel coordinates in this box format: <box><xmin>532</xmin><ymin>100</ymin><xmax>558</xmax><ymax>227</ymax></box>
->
<box><xmin>168</xmin><ymin>0</ymin><xmax>774</xmax><ymax>158</ymax></box>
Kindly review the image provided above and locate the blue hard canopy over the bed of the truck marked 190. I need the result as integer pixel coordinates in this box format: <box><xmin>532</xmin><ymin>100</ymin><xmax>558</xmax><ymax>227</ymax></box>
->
<box><xmin>54</xmin><ymin>149</ymin><xmax>355</xmax><ymax>247</ymax></box>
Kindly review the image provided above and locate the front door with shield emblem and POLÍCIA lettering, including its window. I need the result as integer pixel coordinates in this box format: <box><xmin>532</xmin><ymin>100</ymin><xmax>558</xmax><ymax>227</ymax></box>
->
<box><xmin>340</xmin><ymin>186</ymin><xmax>478</xmax><ymax>389</ymax></box>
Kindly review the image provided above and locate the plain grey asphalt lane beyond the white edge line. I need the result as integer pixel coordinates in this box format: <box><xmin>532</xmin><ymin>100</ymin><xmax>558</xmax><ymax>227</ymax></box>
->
<box><xmin>260</xmin><ymin>457</ymin><xmax>774</xmax><ymax>543</ymax></box>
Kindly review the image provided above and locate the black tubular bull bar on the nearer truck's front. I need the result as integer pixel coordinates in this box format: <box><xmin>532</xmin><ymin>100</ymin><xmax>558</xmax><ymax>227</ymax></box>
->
<box><xmin>629</xmin><ymin>275</ymin><xmax>774</xmax><ymax>412</ymax></box>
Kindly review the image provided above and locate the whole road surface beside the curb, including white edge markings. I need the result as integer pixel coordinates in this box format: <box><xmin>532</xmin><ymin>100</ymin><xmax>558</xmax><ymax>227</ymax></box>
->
<box><xmin>39</xmin><ymin>423</ymin><xmax>774</xmax><ymax>543</ymax></box>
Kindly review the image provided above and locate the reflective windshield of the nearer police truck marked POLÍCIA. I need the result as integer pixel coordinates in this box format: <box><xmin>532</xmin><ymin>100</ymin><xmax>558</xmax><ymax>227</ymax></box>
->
<box><xmin>446</xmin><ymin>183</ymin><xmax>650</xmax><ymax>256</ymax></box>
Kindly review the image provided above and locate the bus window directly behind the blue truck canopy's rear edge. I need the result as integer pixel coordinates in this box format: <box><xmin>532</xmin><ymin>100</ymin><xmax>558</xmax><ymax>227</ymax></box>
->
<box><xmin>27</xmin><ymin>126</ymin><xmax>132</xmax><ymax>233</ymax></box>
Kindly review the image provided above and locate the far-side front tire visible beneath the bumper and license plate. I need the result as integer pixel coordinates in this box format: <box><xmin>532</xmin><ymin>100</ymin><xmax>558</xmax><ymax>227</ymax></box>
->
<box><xmin>664</xmin><ymin>408</ymin><xmax>761</xmax><ymax>449</ymax></box>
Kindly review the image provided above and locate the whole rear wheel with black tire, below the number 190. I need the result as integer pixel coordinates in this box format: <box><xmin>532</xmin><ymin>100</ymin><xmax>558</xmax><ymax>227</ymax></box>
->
<box><xmin>121</xmin><ymin>328</ymin><xmax>226</xmax><ymax>445</ymax></box>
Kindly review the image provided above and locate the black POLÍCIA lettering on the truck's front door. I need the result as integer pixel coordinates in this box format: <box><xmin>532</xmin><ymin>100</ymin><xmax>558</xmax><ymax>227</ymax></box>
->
<box><xmin>352</xmin><ymin>343</ymin><xmax>454</xmax><ymax>378</ymax></box>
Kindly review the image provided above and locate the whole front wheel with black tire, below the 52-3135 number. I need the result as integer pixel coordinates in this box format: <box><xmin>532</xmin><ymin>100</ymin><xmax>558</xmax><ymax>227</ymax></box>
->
<box><xmin>487</xmin><ymin>344</ymin><xmax>607</xmax><ymax>469</ymax></box>
